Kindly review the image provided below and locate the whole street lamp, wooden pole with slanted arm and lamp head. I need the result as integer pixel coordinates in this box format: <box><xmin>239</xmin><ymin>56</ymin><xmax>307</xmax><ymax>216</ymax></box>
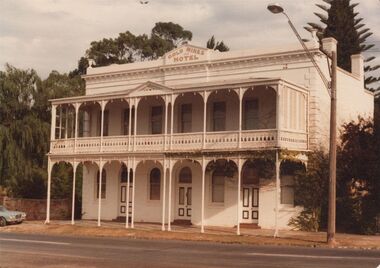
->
<box><xmin>267</xmin><ymin>4</ymin><xmax>337</xmax><ymax>247</ymax></box>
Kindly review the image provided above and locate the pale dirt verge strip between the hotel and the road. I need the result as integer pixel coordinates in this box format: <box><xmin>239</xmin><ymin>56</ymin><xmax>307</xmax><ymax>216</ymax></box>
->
<box><xmin>0</xmin><ymin>222</ymin><xmax>380</xmax><ymax>249</ymax></box>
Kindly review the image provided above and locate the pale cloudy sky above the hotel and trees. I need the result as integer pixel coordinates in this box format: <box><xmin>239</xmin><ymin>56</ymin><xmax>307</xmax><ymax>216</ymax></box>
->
<box><xmin>0</xmin><ymin>0</ymin><xmax>380</xmax><ymax>78</ymax></box>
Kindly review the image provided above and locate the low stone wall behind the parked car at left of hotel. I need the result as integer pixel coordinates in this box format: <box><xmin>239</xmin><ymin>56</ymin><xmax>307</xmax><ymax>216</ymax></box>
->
<box><xmin>2</xmin><ymin>197</ymin><xmax>71</xmax><ymax>220</ymax></box>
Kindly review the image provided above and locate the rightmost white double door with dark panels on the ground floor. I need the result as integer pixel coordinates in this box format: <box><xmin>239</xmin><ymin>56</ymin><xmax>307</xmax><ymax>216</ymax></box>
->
<box><xmin>241</xmin><ymin>185</ymin><xmax>259</xmax><ymax>224</ymax></box>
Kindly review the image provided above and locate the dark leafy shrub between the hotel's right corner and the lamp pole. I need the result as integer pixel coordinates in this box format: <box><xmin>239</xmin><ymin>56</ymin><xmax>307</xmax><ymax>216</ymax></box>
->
<box><xmin>289</xmin><ymin>151</ymin><xmax>329</xmax><ymax>231</ymax></box>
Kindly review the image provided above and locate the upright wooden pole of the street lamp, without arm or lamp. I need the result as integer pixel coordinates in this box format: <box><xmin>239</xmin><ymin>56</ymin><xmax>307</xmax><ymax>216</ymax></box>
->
<box><xmin>327</xmin><ymin>51</ymin><xmax>337</xmax><ymax>247</ymax></box>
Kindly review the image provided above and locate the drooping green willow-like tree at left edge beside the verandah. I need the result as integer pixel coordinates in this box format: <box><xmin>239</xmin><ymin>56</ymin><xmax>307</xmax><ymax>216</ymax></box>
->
<box><xmin>0</xmin><ymin>65</ymin><xmax>84</xmax><ymax>198</ymax></box>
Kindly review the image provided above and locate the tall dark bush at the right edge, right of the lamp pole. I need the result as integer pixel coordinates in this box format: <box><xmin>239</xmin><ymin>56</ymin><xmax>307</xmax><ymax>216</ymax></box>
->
<box><xmin>337</xmin><ymin>117</ymin><xmax>380</xmax><ymax>233</ymax></box>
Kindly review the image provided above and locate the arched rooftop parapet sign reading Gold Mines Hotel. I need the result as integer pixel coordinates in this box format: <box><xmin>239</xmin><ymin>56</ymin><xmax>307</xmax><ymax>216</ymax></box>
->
<box><xmin>165</xmin><ymin>45</ymin><xmax>208</xmax><ymax>64</ymax></box>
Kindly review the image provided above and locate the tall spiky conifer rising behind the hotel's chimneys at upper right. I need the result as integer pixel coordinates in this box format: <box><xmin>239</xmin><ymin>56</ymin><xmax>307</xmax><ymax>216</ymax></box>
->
<box><xmin>305</xmin><ymin>0</ymin><xmax>380</xmax><ymax>92</ymax></box>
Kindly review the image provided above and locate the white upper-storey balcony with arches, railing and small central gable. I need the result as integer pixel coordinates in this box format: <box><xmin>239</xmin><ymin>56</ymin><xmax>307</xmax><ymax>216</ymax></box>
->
<box><xmin>50</xmin><ymin>79</ymin><xmax>308</xmax><ymax>155</ymax></box>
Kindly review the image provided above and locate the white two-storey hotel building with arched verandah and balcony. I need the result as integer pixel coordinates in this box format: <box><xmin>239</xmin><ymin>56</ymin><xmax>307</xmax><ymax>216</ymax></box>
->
<box><xmin>47</xmin><ymin>39</ymin><xmax>373</xmax><ymax>233</ymax></box>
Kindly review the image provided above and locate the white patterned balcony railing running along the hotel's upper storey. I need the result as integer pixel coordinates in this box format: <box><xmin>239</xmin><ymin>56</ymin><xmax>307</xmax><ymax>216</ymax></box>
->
<box><xmin>50</xmin><ymin>129</ymin><xmax>307</xmax><ymax>154</ymax></box>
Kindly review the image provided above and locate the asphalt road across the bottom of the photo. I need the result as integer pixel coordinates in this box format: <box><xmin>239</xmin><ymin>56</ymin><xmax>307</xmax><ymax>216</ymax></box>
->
<box><xmin>0</xmin><ymin>233</ymin><xmax>380</xmax><ymax>268</ymax></box>
